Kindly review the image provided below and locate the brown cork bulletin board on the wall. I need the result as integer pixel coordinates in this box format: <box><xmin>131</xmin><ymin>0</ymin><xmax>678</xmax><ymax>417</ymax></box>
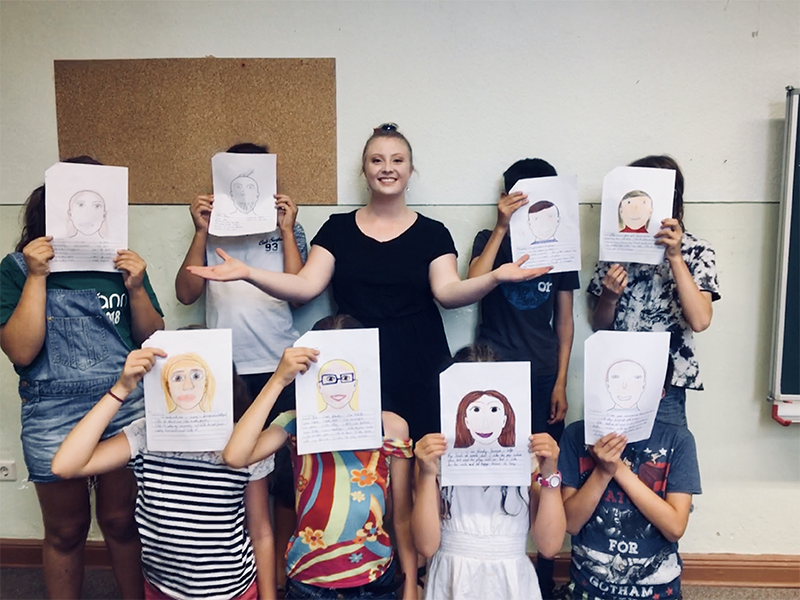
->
<box><xmin>55</xmin><ymin>57</ymin><xmax>336</xmax><ymax>204</ymax></box>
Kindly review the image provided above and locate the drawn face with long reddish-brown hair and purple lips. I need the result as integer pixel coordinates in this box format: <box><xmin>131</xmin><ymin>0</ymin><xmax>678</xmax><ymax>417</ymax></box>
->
<box><xmin>454</xmin><ymin>390</ymin><xmax>516</xmax><ymax>448</ymax></box>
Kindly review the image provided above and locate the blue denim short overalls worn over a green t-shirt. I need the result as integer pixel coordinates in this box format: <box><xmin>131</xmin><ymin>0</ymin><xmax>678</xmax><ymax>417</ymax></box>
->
<box><xmin>12</xmin><ymin>253</ymin><xmax>144</xmax><ymax>483</ymax></box>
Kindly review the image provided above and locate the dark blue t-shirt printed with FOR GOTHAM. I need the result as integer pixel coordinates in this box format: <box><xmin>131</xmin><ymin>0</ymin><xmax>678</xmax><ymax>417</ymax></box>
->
<box><xmin>558</xmin><ymin>421</ymin><xmax>701</xmax><ymax>600</ymax></box>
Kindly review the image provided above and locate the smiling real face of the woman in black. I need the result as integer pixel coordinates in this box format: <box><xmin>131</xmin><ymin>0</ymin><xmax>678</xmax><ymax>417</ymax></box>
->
<box><xmin>363</xmin><ymin>137</ymin><xmax>414</xmax><ymax>196</ymax></box>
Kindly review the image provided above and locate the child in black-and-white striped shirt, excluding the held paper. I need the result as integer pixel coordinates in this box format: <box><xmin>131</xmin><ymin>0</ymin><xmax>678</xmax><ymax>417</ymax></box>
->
<box><xmin>52</xmin><ymin>348</ymin><xmax>277</xmax><ymax>600</ymax></box>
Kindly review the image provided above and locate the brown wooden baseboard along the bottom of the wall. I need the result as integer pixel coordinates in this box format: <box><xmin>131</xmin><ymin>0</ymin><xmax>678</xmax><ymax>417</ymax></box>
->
<box><xmin>0</xmin><ymin>539</ymin><xmax>800</xmax><ymax>588</ymax></box>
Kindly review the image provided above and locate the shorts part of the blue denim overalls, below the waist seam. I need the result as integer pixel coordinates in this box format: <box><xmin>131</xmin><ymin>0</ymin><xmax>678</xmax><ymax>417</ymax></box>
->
<box><xmin>19</xmin><ymin>375</ymin><xmax>144</xmax><ymax>483</ymax></box>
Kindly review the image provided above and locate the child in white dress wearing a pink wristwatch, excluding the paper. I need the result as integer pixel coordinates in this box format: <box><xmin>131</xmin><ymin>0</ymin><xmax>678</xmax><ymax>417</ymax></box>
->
<box><xmin>411</xmin><ymin>344</ymin><xmax>566</xmax><ymax>600</ymax></box>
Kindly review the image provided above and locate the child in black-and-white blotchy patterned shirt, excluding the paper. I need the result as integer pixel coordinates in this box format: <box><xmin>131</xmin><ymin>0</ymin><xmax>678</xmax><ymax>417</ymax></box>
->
<box><xmin>588</xmin><ymin>156</ymin><xmax>720</xmax><ymax>427</ymax></box>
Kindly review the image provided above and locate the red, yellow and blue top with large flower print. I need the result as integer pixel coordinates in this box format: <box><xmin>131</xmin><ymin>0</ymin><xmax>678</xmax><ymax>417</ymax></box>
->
<box><xmin>273</xmin><ymin>411</ymin><xmax>413</xmax><ymax>588</ymax></box>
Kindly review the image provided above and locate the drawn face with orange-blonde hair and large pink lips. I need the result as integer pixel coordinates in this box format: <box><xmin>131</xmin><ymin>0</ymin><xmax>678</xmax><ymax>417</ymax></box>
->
<box><xmin>161</xmin><ymin>352</ymin><xmax>216</xmax><ymax>414</ymax></box>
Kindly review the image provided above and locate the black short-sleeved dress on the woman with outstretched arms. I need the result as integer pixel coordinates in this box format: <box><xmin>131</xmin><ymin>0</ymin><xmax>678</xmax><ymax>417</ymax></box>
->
<box><xmin>311</xmin><ymin>211</ymin><xmax>456</xmax><ymax>439</ymax></box>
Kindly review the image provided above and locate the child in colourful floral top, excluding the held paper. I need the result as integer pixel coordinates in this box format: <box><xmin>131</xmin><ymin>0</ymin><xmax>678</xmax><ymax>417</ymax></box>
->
<box><xmin>223</xmin><ymin>315</ymin><xmax>417</xmax><ymax>600</ymax></box>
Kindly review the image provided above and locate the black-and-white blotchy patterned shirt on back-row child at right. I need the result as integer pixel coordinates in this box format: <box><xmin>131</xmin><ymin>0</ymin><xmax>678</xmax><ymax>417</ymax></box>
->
<box><xmin>588</xmin><ymin>232</ymin><xmax>720</xmax><ymax>390</ymax></box>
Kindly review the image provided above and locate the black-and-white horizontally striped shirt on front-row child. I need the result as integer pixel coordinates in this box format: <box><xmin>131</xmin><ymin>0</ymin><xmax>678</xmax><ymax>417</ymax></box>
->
<box><xmin>124</xmin><ymin>419</ymin><xmax>274</xmax><ymax>600</ymax></box>
